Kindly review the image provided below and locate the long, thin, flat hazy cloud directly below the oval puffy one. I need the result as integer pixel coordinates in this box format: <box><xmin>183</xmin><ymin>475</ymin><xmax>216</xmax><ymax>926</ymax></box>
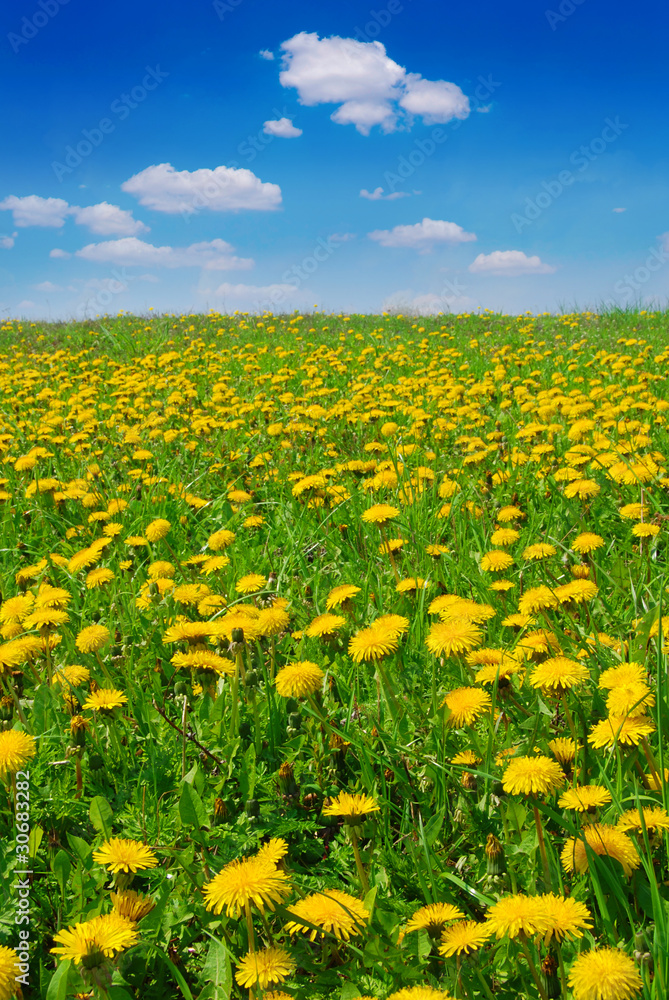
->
<box><xmin>76</xmin><ymin>236</ymin><xmax>254</xmax><ymax>271</ymax></box>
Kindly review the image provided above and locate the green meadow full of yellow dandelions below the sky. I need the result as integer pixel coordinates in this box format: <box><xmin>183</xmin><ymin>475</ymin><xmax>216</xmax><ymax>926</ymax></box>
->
<box><xmin>0</xmin><ymin>312</ymin><xmax>669</xmax><ymax>1000</ymax></box>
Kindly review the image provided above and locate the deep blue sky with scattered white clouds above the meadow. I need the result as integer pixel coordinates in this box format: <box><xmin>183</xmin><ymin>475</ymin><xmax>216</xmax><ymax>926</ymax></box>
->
<box><xmin>0</xmin><ymin>0</ymin><xmax>669</xmax><ymax>319</ymax></box>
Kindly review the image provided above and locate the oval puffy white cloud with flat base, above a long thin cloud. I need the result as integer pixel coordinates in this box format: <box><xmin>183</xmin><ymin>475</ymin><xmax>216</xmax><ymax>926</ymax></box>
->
<box><xmin>121</xmin><ymin>163</ymin><xmax>281</xmax><ymax>215</ymax></box>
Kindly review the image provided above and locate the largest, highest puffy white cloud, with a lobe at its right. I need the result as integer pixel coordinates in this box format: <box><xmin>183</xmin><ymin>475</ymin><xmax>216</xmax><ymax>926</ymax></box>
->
<box><xmin>279</xmin><ymin>31</ymin><xmax>469</xmax><ymax>135</ymax></box>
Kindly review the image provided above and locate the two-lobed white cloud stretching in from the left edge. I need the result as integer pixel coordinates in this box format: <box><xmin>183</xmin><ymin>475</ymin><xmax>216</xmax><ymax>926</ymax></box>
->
<box><xmin>0</xmin><ymin>194</ymin><xmax>149</xmax><ymax>236</ymax></box>
